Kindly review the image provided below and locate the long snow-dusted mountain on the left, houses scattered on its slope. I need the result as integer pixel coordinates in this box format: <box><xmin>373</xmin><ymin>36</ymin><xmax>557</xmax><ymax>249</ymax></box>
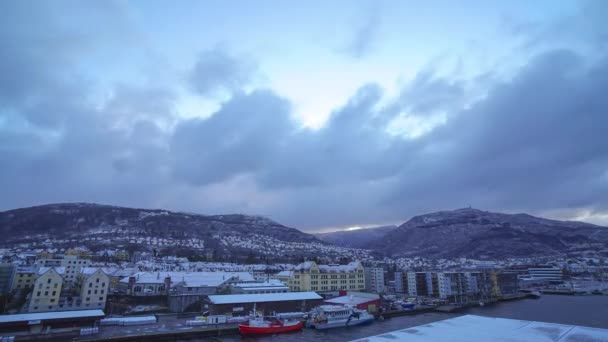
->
<box><xmin>0</xmin><ymin>203</ymin><xmax>338</xmax><ymax>256</ymax></box>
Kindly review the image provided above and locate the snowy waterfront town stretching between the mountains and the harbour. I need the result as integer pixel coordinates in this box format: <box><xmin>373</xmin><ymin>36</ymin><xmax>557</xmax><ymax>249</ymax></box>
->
<box><xmin>0</xmin><ymin>241</ymin><xmax>608</xmax><ymax>340</ymax></box>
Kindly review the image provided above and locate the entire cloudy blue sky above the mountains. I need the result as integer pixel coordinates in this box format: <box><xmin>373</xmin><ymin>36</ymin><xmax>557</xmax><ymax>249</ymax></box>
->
<box><xmin>0</xmin><ymin>0</ymin><xmax>608</xmax><ymax>232</ymax></box>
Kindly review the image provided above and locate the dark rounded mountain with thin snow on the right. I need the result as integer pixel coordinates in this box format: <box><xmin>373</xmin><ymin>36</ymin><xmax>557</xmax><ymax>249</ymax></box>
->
<box><xmin>365</xmin><ymin>208</ymin><xmax>608</xmax><ymax>259</ymax></box>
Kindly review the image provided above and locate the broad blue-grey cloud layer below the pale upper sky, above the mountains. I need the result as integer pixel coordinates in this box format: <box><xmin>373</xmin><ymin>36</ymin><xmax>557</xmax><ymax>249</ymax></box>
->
<box><xmin>0</xmin><ymin>2</ymin><xmax>608</xmax><ymax>229</ymax></box>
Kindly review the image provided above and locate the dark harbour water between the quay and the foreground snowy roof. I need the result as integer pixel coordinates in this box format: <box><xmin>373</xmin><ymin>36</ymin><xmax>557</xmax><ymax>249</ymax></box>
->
<box><xmin>184</xmin><ymin>295</ymin><xmax>608</xmax><ymax>342</ymax></box>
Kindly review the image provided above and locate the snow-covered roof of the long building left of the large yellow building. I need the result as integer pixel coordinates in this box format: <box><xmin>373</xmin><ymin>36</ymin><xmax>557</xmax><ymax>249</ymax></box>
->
<box><xmin>120</xmin><ymin>272</ymin><xmax>255</xmax><ymax>287</ymax></box>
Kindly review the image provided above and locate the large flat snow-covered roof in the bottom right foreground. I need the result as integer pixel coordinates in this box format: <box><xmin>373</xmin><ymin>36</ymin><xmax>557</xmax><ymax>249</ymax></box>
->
<box><xmin>356</xmin><ymin>315</ymin><xmax>608</xmax><ymax>342</ymax></box>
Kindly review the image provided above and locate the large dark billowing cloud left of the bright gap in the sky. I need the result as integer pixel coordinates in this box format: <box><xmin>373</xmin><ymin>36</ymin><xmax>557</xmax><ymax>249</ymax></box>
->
<box><xmin>171</xmin><ymin>91</ymin><xmax>294</xmax><ymax>185</ymax></box>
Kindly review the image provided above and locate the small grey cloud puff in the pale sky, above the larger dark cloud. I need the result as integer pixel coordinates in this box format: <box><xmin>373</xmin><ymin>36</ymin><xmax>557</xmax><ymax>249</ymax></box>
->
<box><xmin>189</xmin><ymin>48</ymin><xmax>257</xmax><ymax>96</ymax></box>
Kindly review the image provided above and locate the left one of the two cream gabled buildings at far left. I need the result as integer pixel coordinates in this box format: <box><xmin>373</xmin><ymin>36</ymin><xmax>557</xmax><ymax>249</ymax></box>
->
<box><xmin>27</xmin><ymin>267</ymin><xmax>65</xmax><ymax>312</ymax></box>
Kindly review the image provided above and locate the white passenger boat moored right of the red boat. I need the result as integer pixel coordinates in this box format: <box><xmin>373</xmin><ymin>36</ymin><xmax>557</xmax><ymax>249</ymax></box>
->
<box><xmin>306</xmin><ymin>305</ymin><xmax>374</xmax><ymax>329</ymax></box>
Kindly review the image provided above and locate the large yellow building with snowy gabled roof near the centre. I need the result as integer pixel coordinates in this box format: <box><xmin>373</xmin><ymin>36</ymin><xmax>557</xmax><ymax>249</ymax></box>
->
<box><xmin>277</xmin><ymin>261</ymin><xmax>365</xmax><ymax>292</ymax></box>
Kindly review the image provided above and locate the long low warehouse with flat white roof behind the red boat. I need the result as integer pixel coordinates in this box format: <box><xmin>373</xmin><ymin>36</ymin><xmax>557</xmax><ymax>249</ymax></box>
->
<box><xmin>206</xmin><ymin>292</ymin><xmax>323</xmax><ymax>316</ymax></box>
